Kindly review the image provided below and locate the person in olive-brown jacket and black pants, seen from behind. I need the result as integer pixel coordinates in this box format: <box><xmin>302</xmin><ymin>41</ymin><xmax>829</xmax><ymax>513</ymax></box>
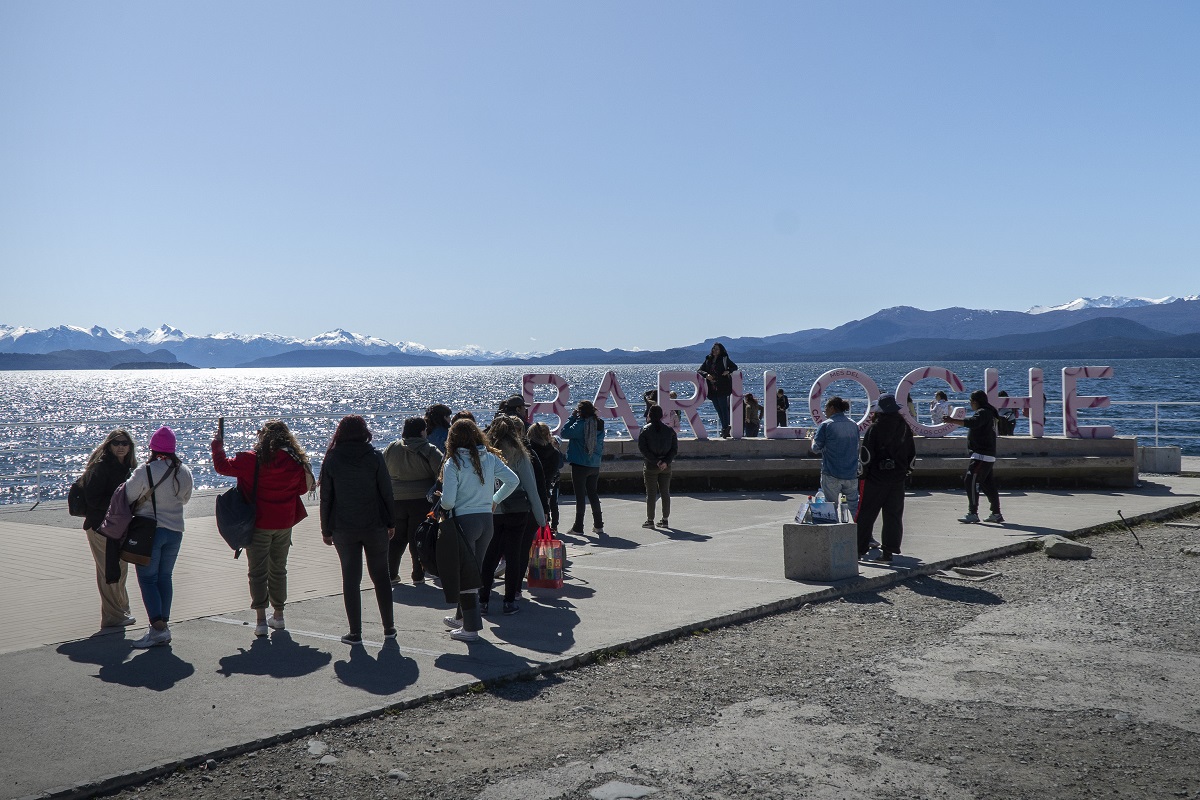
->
<box><xmin>383</xmin><ymin>417</ymin><xmax>450</xmax><ymax>585</ymax></box>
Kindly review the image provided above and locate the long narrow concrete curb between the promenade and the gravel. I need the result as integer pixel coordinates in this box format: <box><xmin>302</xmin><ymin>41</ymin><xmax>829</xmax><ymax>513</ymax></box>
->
<box><xmin>25</xmin><ymin>500</ymin><xmax>1200</xmax><ymax>800</ymax></box>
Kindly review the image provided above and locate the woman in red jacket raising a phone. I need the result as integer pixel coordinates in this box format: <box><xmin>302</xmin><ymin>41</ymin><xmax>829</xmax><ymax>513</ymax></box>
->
<box><xmin>212</xmin><ymin>419</ymin><xmax>316</xmax><ymax>636</ymax></box>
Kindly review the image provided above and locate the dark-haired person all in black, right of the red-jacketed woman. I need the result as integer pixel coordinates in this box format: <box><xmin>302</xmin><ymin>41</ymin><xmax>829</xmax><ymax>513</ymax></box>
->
<box><xmin>320</xmin><ymin>414</ymin><xmax>396</xmax><ymax>644</ymax></box>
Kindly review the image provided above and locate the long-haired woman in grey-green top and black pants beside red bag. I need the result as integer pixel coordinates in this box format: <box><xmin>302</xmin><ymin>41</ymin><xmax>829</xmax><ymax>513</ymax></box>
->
<box><xmin>479</xmin><ymin>416</ymin><xmax>546</xmax><ymax>615</ymax></box>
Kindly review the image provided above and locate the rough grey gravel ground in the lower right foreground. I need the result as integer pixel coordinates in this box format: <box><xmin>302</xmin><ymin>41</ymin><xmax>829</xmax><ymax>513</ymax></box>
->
<box><xmin>120</xmin><ymin>519</ymin><xmax>1200</xmax><ymax>800</ymax></box>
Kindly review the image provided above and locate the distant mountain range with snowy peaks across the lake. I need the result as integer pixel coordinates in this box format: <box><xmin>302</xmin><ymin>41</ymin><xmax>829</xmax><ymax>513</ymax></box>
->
<box><xmin>0</xmin><ymin>295</ymin><xmax>1200</xmax><ymax>369</ymax></box>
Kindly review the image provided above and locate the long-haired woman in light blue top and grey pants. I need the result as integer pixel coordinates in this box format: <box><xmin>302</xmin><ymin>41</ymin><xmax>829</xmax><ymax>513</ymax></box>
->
<box><xmin>437</xmin><ymin>420</ymin><xmax>520</xmax><ymax>642</ymax></box>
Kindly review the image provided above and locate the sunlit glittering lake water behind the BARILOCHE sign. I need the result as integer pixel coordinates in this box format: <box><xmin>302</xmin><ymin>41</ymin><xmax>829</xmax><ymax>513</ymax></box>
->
<box><xmin>0</xmin><ymin>354</ymin><xmax>1200</xmax><ymax>503</ymax></box>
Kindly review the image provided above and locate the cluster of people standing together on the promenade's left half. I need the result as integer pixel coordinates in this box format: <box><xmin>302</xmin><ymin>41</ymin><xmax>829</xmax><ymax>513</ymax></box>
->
<box><xmin>82</xmin><ymin>396</ymin><xmax>609</xmax><ymax>648</ymax></box>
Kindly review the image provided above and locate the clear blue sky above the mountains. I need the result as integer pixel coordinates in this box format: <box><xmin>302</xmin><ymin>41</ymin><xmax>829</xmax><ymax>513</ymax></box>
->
<box><xmin>0</xmin><ymin>0</ymin><xmax>1200</xmax><ymax>350</ymax></box>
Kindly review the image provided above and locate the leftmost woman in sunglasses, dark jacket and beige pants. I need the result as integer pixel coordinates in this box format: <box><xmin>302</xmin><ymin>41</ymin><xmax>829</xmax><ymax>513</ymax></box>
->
<box><xmin>83</xmin><ymin>428</ymin><xmax>138</xmax><ymax>627</ymax></box>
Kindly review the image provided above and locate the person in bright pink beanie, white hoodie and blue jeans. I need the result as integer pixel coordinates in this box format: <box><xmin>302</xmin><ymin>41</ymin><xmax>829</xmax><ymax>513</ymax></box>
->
<box><xmin>125</xmin><ymin>426</ymin><xmax>192</xmax><ymax>648</ymax></box>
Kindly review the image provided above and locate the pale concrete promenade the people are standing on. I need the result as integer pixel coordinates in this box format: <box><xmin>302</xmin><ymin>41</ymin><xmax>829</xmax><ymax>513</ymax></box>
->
<box><xmin>0</xmin><ymin>474</ymin><xmax>1200</xmax><ymax>798</ymax></box>
